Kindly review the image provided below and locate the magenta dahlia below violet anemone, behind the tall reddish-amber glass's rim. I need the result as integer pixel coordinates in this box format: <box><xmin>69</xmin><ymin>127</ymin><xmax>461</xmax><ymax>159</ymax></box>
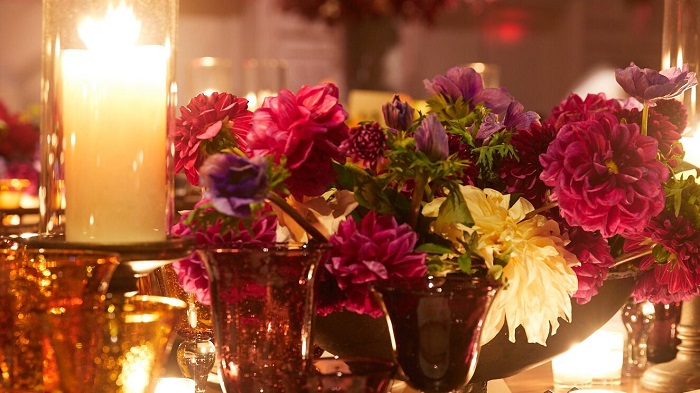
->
<box><xmin>172</xmin><ymin>199</ymin><xmax>277</xmax><ymax>305</ymax></box>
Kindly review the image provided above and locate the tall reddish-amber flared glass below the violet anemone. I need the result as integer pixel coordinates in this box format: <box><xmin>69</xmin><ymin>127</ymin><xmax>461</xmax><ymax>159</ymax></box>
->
<box><xmin>197</xmin><ymin>243</ymin><xmax>327</xmax><ymax>393</ymax></box>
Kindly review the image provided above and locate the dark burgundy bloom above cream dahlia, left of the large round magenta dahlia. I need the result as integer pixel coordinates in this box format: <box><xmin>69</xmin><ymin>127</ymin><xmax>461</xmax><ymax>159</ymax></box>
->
<box><xmin>500</xmin><ymin>123</ymin><xmax>557</xmax><ymax>207</ymax></box>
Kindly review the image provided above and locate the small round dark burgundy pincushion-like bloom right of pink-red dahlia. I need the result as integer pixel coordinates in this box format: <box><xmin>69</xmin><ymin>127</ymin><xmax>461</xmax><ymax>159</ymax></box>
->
<box><xmin>340</xmin><ymin>121</ymin><xmax>387</xmax><ymax>168</ymax></box>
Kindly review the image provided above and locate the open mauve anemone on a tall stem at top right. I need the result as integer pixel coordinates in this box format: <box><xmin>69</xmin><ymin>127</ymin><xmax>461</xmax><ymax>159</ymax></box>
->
<box><xmin>615</xmin><ymin>62</ymin><xmax>698</xmax><ymax>106</ymax></box>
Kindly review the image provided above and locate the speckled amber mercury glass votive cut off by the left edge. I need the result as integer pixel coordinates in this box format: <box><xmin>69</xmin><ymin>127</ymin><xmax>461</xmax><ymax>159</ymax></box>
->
<box><xmin>0</xmin><ymin>246</ymin><xmax>119</xmax><ymax>392</ymax></box>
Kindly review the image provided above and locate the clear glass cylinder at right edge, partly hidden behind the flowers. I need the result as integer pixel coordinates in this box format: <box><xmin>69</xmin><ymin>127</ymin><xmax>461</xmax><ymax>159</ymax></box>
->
<box><xmin>661</xmin><ymin>0</ymin><xmax>700</xmax><ymax>136</ymax></box>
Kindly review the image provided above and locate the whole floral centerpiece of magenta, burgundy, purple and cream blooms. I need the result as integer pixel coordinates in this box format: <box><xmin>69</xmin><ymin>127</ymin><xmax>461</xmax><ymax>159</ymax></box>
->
<box><xmin>173</xmin><ymin>63</ymin><xmax>700</xmax><ymax>345</ymax></box>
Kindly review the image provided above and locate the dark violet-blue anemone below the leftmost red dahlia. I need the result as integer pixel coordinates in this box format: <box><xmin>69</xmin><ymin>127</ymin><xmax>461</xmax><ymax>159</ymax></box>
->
<box><xmin>200</xmin><ymin>153</ymin><xmax>268</xmax><ymax>218</ymax></box>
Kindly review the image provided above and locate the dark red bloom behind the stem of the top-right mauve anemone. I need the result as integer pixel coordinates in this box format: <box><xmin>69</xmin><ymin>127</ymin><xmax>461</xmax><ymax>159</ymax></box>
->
<box><xmin>617</xmin><ymin>106</ymin><xmax>684</xmax><ymax>168</ymax></box>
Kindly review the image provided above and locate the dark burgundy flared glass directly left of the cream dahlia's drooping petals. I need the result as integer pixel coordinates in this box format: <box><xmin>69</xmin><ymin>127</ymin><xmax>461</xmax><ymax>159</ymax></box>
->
<box><xmin>374</xmin><ymin>276</ymin><xmax>500</xmax><ymax>393</ymax></box>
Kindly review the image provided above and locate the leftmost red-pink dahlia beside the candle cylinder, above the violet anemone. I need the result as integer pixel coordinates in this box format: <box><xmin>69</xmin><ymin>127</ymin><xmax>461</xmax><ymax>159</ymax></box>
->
<box><xmin>174</xmin><ymin>93</ymin><xmax>253</xmax><ymax>186</ymax></box>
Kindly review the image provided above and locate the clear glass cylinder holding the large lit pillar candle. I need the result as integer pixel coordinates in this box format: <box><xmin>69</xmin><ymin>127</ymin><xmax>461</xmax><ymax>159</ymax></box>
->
<box><xmin>39</xmin><ymin>0</ymin><xmax>178</xmax><ymax>244</ymax></box>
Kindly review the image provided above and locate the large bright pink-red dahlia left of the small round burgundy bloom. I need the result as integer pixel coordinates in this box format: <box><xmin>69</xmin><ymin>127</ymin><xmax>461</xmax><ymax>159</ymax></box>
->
<box><xmin>247</xmin><ymin>83</ymin><xmax>348</xmax><ymax>200</ymax></box>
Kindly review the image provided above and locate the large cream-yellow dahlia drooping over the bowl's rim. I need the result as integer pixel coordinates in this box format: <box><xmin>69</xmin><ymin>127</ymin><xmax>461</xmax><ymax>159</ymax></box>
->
<box><xmin>427</xmin><ymin>186</ymin><xmax>579</xmax><ymax>345</ymax></box>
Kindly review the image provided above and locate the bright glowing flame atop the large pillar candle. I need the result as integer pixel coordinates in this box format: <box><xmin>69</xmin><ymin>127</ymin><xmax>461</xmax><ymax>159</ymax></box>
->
<box><xmin>78</xmin><ymin>3</ymin><xmax>141</xmax><ymax>50</ymax></box>
